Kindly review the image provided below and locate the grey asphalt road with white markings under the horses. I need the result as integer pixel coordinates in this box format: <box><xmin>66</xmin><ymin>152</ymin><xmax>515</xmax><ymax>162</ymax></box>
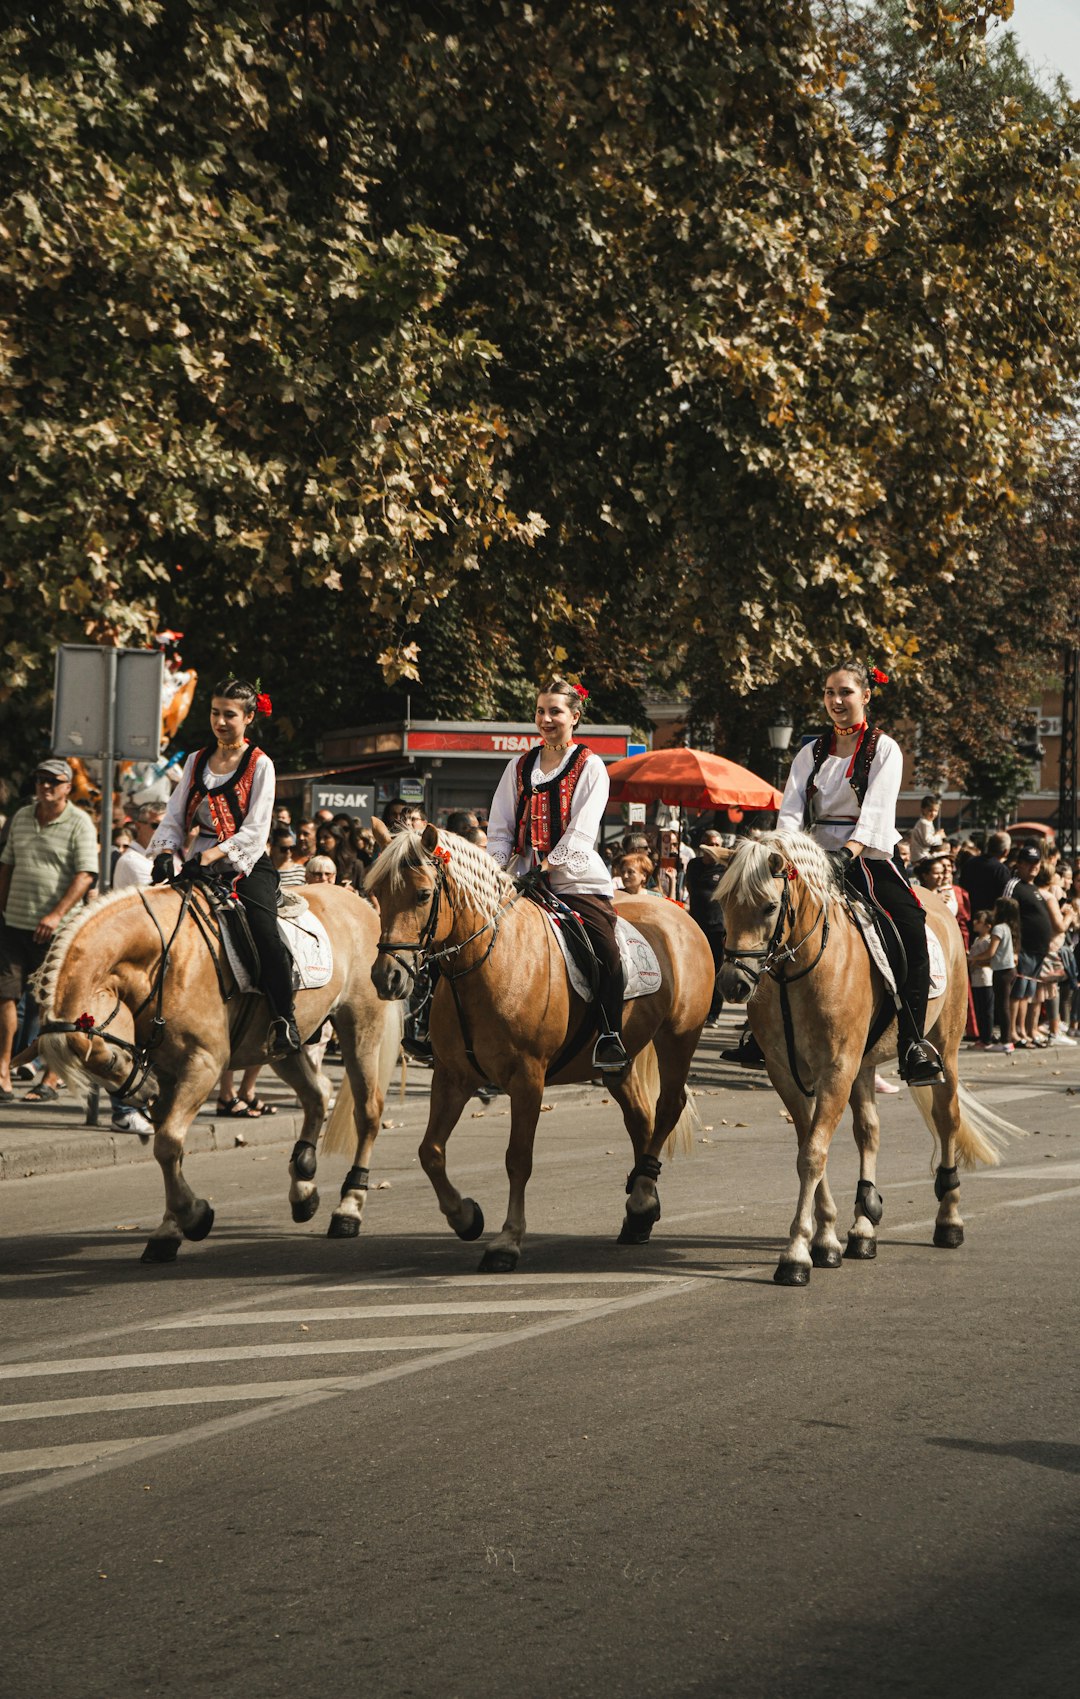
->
<box><xmin>0</xmin><ymin>1019</ymin><xmax>1080</xmax><ymax>1699</ymax></box>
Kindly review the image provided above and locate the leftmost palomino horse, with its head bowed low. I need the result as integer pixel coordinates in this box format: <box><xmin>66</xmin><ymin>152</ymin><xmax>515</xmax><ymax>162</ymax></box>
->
<box><xmin>37</xmin><ymin>885</ymin><xmax>401</xmax><ymax>1262</ymax></box>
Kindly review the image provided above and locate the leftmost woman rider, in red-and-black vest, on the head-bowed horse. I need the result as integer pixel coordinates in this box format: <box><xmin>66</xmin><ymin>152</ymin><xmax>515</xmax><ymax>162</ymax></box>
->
<box><xmin>149</xmin><ymin>678</ymin><xmax>301</xmax><ymax>1058</ymax></box>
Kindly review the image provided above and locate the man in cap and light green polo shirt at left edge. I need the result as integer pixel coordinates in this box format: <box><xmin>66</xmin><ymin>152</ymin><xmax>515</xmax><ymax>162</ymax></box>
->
<box><xmin>0</xmin><ymin>761</ymin><xmax>98</xmax><ymax>1103</ymax></box>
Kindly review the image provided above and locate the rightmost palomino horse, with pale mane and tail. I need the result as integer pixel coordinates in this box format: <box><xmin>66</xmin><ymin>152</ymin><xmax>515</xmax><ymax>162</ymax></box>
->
<box><xmin>717</xmin><ymin>833</ymin><xmax>1017</xmax><ymax>1286</ymax></box>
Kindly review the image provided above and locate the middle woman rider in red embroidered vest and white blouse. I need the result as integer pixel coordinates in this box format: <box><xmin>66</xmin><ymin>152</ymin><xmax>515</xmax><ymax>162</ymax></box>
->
<box><xmin>487</xmin><ymin>678</ymin><xmax>630</xmax><ymax>1074</ymax></box>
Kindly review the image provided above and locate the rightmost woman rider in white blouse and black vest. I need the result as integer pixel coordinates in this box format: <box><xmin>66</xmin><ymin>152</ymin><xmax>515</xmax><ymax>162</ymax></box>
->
<box><xmin>776</xmin><ymin>661</ymin><xmax>944</xmax><ymax>1086</ymax></box>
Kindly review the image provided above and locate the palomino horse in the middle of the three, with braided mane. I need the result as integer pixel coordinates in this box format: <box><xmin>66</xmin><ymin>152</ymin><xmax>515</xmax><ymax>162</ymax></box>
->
<box><xmin>367</xmin><ymin>826</ymin><xmax>713</xmax><ymax>1274</ymax></box>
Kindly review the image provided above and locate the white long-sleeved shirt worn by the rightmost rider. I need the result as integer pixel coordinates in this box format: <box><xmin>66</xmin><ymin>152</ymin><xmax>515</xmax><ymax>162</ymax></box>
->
<box><xmin>776</xmin><ymin>732</ymin><xmax>903</xmax><ymax>861</ymax></box>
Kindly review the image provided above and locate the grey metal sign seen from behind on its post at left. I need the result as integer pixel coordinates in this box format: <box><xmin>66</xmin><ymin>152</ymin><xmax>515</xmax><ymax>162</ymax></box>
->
<box><xmin>53</xmin><ymin>644</ymin><xmax>165</xmax><ymax>892</ymax></box>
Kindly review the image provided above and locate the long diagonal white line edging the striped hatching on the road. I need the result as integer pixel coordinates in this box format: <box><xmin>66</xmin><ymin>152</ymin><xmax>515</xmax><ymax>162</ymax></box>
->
<box><xmin>0</xmin><ymin>1279</ymin><xmax>700</xmax><ymax>1505</ymax></box>
